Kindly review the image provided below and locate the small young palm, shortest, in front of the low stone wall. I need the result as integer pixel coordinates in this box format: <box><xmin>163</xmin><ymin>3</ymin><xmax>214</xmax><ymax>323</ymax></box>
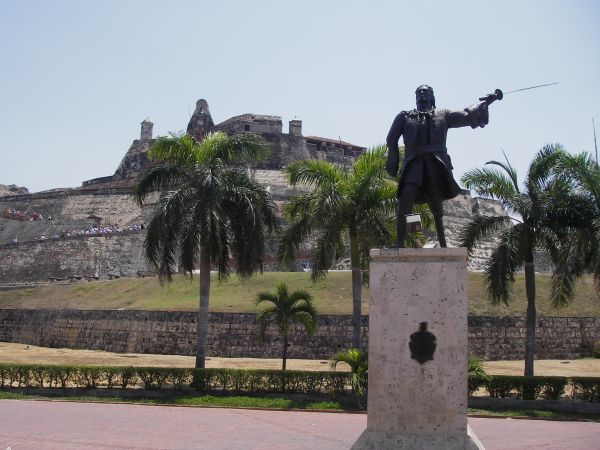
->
<box><xmin>256</xmin><ymin>283</ymin><xmax>317</xmax><ymax>370</ymax></box>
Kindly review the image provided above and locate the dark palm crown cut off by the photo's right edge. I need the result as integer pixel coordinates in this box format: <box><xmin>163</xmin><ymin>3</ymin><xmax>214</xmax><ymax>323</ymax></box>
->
<box><xmin>552</xmin><ymin>153</ymin><xmax>600</xmax><ymax>306</ymax></box>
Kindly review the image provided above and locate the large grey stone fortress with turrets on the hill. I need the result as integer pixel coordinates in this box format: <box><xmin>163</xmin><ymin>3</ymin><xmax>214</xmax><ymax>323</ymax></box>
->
<box><xmin>0</xmin><ymin>99</ymin><xmax>503</xmax><ymax>286</ymax></box>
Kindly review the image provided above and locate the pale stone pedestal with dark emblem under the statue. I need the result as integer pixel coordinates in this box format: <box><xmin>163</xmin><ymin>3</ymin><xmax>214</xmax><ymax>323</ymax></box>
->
<box><xmin>352</xmin><ymin>248</ymin><xmax>483</xmax><ymax>450</ymax></box>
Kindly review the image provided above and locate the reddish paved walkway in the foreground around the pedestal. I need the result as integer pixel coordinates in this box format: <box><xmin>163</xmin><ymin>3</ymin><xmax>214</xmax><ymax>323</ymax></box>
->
<box><xmin>0</xmin><ymin>400</ymin><xmax>600</xmax><ymax>450</ymax></box>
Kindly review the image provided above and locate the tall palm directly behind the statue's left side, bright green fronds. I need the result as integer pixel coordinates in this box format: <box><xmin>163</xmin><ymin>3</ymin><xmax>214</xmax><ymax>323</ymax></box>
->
<box><xmin>277</xmin><ymin>146</ymin><xmax>396</xmax><ymax>348</ymax></box>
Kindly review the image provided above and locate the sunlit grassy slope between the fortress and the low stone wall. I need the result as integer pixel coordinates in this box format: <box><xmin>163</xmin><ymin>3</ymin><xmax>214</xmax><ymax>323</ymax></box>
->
<box><xmin>0</xmin><ymin>271</ymin><xmax>600</xmax><ymax>316</ymax></box>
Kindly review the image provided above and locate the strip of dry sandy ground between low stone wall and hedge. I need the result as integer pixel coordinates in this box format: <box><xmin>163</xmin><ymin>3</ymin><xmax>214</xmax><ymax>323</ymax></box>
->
<box><xmin>0</xmin><ymin>342</ymin><xmax>600</xmax><ymax>377</ymax></box>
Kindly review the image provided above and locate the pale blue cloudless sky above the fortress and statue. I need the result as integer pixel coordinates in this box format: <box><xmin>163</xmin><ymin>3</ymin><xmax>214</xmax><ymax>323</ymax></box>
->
<box><xmin>0</xmin><ymin>0</ymin><xmax>600</xmax><ymax>192</ymax></box>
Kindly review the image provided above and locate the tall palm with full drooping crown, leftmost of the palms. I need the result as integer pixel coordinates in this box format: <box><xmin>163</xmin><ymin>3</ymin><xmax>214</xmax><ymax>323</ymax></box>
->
<box><xmin>133</xmin><ymin>132</ymin><xmax>277</xmax><ymax>368</ymax></box>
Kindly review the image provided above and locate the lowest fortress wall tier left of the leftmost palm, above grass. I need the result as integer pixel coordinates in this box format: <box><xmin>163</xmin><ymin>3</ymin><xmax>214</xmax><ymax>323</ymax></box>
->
<box><xmin>0</xmin><ymin>232</ymin><xmax>147</xmax><ymax>283</ymax></box>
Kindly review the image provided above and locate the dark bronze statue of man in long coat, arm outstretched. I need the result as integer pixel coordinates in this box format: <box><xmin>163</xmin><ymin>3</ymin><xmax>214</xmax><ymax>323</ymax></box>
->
<box><xmin>386</xmin><ymin>85</ymin><xmax>489</xmax><ymax>247</ymax></box>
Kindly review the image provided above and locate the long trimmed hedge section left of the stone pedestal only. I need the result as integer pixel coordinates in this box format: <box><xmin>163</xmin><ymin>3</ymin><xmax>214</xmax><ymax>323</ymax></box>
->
<box><xmin>0</xmin><ymin>363</ymin><xmax>351</xmax><ymax>396</ymax></box>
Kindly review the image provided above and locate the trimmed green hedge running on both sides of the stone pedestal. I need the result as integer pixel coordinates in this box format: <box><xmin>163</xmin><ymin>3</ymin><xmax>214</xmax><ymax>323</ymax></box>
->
<box><xmin>0</xmin><ymin>363</ymin><xmax>600</xmax><ymax>402</ymax></box>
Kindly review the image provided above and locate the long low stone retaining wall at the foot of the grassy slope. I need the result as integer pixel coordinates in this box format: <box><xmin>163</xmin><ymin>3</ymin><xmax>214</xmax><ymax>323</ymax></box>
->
<box><xmin>0</xmin><ymin>309</ymin><xmax>600</xmax><ymax>360</ymax></box>
